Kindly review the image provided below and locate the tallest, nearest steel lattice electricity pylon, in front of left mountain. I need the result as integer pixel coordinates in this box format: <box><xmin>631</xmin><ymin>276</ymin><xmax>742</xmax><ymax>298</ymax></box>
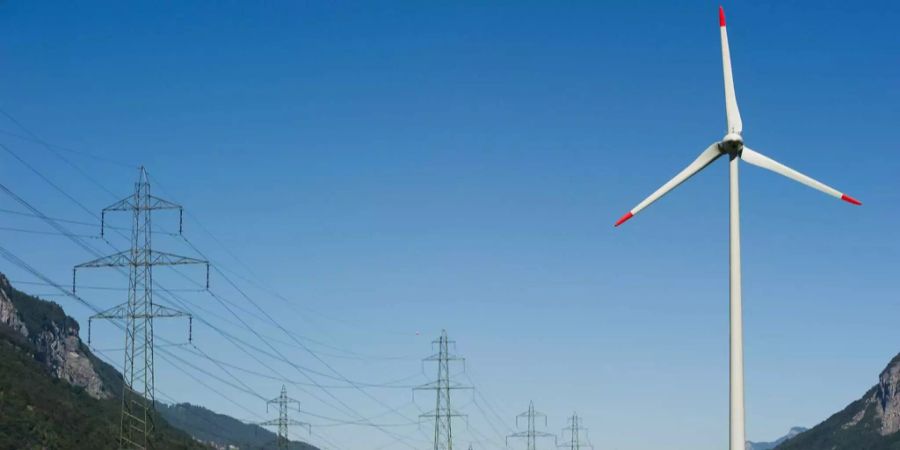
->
<box><xmin>72</xmin><ymin>166</ymin><xmax>209</xmax><ymax>450</ymax></box>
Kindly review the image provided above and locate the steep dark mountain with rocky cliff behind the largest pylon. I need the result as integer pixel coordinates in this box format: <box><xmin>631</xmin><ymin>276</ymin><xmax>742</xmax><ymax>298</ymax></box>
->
<box><xmin>0</xmin><ymin>274</ymin><xmax>208</xmax><ymax>450</ymax></box>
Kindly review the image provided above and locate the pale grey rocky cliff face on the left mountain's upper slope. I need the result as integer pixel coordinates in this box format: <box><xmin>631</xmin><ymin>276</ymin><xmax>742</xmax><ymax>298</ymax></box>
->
<box><xmin>0</xmin><ymin>274</ymin><xmax>111</xmax><ymax>399</ymax></box>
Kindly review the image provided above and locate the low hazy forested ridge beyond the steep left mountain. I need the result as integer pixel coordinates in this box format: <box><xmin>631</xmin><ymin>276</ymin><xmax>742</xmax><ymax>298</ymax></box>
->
<box><xmin>157</xmin><ymin>403</ymin><xmax>318</xmax><ymax>450</ymax></box>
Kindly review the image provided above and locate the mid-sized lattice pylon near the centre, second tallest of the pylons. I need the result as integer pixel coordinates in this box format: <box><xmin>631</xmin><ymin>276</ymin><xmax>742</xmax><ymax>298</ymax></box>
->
<box><xmin>414</xmin><ymin>330</ymin><xmax>472</xmax><ymax>450</ymax></box>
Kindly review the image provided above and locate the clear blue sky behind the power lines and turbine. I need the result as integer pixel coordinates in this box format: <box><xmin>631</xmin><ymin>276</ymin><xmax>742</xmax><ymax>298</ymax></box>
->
<box><xmin>0</xmin><ymin>1</ymin><xmax>900</xmax><ymax>450</ymax></box>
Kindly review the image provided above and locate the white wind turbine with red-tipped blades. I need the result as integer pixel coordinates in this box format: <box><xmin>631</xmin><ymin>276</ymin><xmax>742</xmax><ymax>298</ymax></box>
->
<box><xmin>616</xmin><ymin>7</ymin><xmax>861</xmax><ymax>450</ymax></box>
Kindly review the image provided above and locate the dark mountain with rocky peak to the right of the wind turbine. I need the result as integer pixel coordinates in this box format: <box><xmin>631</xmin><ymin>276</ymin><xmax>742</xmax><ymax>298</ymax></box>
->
<box><xmin>776</xmin><ymin>354</ymin><xmax>900</xmax><ymax>450</ymax></box>
